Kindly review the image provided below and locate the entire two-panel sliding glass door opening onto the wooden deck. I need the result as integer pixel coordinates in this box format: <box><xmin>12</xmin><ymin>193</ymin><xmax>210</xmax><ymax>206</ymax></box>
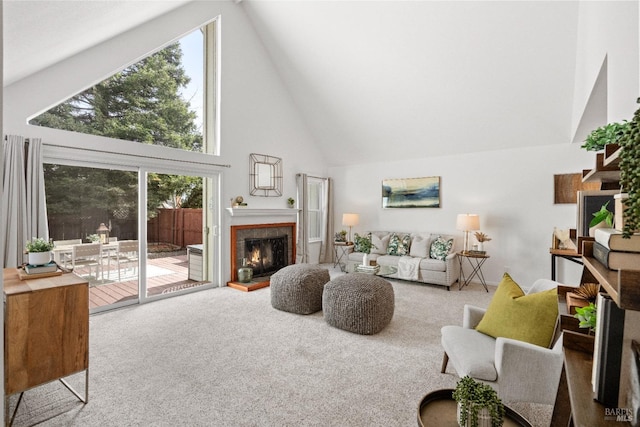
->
<box><xmin>45</xmin><ymin>164</ymin><xmax>219</xmax><ymax>312</ymax></box>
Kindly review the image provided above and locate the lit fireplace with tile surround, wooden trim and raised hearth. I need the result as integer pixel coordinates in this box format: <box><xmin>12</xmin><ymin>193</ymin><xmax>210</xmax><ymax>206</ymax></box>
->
<box><xmin>227</xmin><ymin>222</ymin><xmax>296</xmax><ymax>291</ymax></box>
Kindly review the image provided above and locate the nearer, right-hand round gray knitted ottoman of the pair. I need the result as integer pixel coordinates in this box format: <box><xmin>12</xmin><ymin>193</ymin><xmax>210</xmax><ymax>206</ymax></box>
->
<box><xmin>322</xmin><ymin>273</ymin><xmax>395</xmax><ymax>335</ymax></box>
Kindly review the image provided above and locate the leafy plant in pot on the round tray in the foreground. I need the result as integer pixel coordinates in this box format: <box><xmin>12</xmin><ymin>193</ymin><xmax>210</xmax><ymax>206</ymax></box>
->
<box><xmin>452</xmin><ymin>376</ymin><xmax>505</xmax><ymax>427</ymax></box>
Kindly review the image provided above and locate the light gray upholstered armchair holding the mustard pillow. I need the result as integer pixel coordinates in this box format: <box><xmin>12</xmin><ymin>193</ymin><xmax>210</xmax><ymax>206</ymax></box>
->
<box><xmin>441</xmin><ymin>279</ymin><xmax>563</xmax><ymax>404</ymax></box>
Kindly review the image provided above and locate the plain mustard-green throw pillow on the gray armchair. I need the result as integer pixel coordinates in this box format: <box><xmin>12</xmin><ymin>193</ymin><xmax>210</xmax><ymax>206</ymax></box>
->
<box><xmin>476</xmin><ymin>273</ymin><xmax>558</xmax><ymax>347</ymax></box>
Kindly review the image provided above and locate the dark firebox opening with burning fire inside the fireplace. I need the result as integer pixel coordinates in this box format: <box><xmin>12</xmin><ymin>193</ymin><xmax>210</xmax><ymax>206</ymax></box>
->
<box><xmin>244</xmin><ymin>235</ymin><xmax>288</xmax><ymax>277</ymax></box>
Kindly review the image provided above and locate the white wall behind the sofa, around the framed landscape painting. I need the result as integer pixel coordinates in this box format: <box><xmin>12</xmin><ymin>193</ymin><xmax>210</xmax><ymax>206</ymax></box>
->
<box><xmin>330</xmin><ymin>144</ymin><xmax>595</xmax><ymax>286</ymax></box>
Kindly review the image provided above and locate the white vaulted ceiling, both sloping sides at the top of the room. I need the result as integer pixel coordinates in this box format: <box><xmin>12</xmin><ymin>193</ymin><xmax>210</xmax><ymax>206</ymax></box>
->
<box><xmin>3</xmin><ymin>0</ymin><xmax>579</xmax><ymax>165</ymax></box>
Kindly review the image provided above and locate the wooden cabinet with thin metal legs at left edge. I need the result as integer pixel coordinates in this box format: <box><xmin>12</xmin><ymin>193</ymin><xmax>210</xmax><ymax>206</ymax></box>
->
<box><xmin>3</xmin><ymin>268</ymin><xmax>89</xmax><ymax>425</ymax></box>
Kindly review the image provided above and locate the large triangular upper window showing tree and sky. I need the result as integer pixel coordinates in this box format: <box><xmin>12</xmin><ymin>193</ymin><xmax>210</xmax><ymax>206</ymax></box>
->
<box><xmin>30</xmin><ymin>24</ymin><xmax>210</xmax><ymax>152</ymax></box>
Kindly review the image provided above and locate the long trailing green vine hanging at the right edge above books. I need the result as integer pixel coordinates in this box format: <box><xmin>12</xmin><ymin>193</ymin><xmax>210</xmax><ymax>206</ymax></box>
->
<box><xmin>618</xmin><ymin>98</ymin><xmax>640</xmax><ymax>239</ymax></box>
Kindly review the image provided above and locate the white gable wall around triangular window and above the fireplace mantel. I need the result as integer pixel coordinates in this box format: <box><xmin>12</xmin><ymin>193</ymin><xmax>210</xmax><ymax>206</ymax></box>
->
<box><xmin>4</xmin><ymin>1</ymin><xmax>326</xmax><ymax>283</ymax></box>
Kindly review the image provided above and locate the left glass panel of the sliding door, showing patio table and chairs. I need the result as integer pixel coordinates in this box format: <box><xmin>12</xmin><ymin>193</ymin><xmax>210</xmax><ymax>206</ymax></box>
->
<box><xmin>44</xmin><ymin>164</ymin><xmax>140</xmax><ymax>310</ymax></box>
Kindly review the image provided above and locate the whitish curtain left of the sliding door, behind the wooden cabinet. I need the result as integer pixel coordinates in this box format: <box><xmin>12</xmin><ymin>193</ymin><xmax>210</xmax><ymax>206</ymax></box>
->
<box><xmin>0</xmin><ymin>135</ymin><xmax>49</xmax><ymax>267</ymax></box>
